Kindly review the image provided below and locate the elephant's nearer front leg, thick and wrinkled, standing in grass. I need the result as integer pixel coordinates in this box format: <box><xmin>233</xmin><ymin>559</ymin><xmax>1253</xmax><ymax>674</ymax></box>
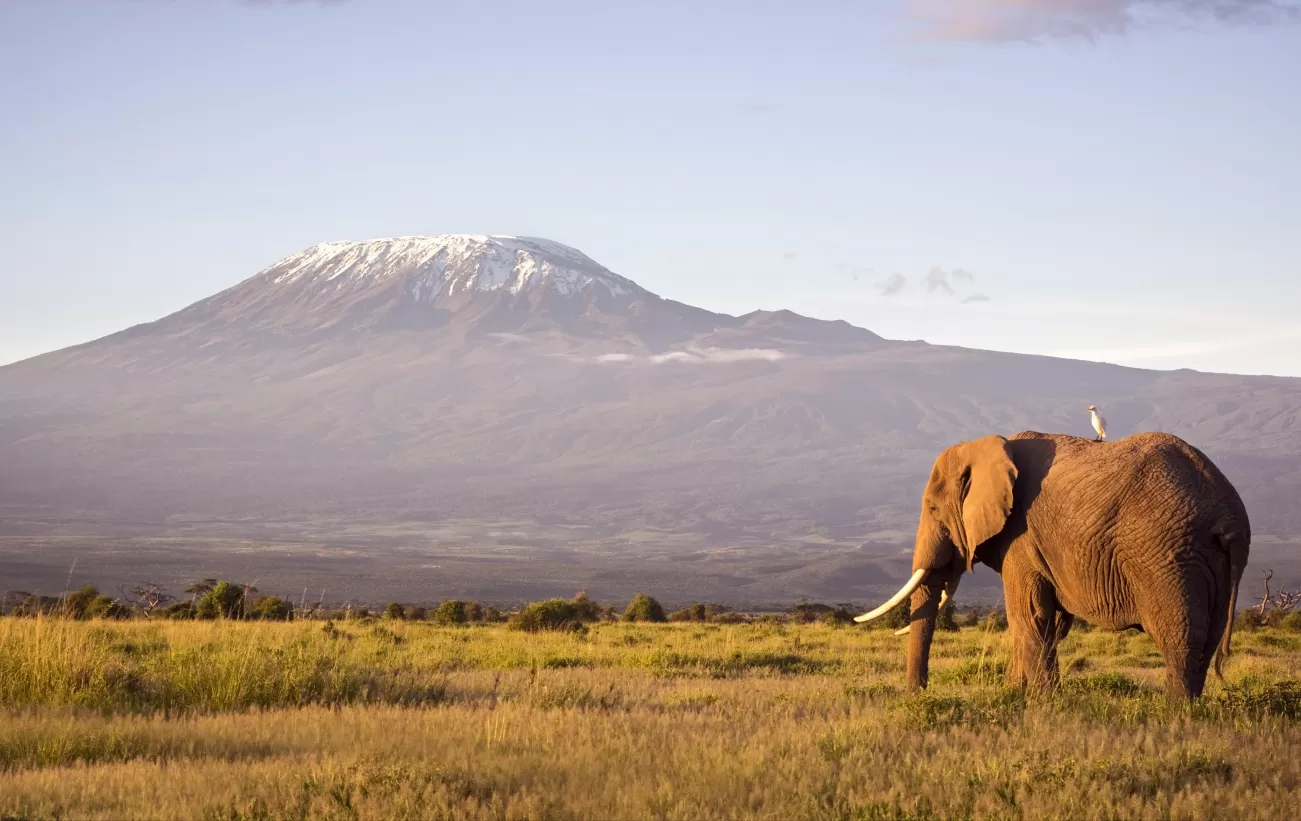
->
<box><xmin>1003</xmin><ymin>557</ymin><xmax>1069</xmax><ymax>692</ymax></box>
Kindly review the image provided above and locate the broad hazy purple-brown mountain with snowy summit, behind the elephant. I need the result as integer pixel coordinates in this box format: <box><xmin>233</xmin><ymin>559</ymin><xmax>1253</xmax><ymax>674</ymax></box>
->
<box><xmin>0</xmin><ymin>237</ymin><xmax>1301</xmax><ymax>595</ymax></box>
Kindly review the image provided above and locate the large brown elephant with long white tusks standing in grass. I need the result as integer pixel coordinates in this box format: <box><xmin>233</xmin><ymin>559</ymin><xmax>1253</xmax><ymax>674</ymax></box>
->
<box><xmin>855</xmin><ymin>431</ymin><xmax>1252</xmax><ymax>703</ymax></box>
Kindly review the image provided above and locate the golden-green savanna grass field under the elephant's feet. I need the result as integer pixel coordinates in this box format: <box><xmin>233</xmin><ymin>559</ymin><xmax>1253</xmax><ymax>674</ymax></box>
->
<box><xmin>0</xmin><ymin>618</ymin><xmax>1301</xmax><ymax>820</ymax></box>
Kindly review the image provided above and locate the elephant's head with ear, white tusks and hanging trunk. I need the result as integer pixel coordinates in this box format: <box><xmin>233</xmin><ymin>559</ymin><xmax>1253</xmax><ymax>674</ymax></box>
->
<box><xmin>855</xmin><ymin>436</ymin><xmax>1016</xmax><ymax>688</ymax></box>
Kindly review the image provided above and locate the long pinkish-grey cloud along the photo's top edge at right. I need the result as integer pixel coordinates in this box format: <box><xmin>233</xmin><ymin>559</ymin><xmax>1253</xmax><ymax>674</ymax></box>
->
<box><xmin>909</xmin><ymin>0</ymin><xmax>1301</xmax><ymax>42</ymax></box>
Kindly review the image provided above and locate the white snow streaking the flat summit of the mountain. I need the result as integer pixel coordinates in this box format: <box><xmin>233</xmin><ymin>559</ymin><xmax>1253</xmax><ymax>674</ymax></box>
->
<box><xmin>258</xmin><ymin>234</ymin><xmax>641</xmax><ymax>302</ymax></box>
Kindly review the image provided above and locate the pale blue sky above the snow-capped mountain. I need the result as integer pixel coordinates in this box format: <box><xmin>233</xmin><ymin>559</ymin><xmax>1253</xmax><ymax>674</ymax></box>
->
<box><xmin>0</xmin><ymin>0</ymin><xmax>1301</xmax><ymax>376</ymax></box>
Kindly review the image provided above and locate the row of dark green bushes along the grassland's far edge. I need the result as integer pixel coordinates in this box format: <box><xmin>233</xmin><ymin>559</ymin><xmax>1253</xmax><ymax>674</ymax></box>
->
<box><xmin>0</xmin><ymin>579</ymin><xmax>1301</xmax><ymax>631</ymax></box>
